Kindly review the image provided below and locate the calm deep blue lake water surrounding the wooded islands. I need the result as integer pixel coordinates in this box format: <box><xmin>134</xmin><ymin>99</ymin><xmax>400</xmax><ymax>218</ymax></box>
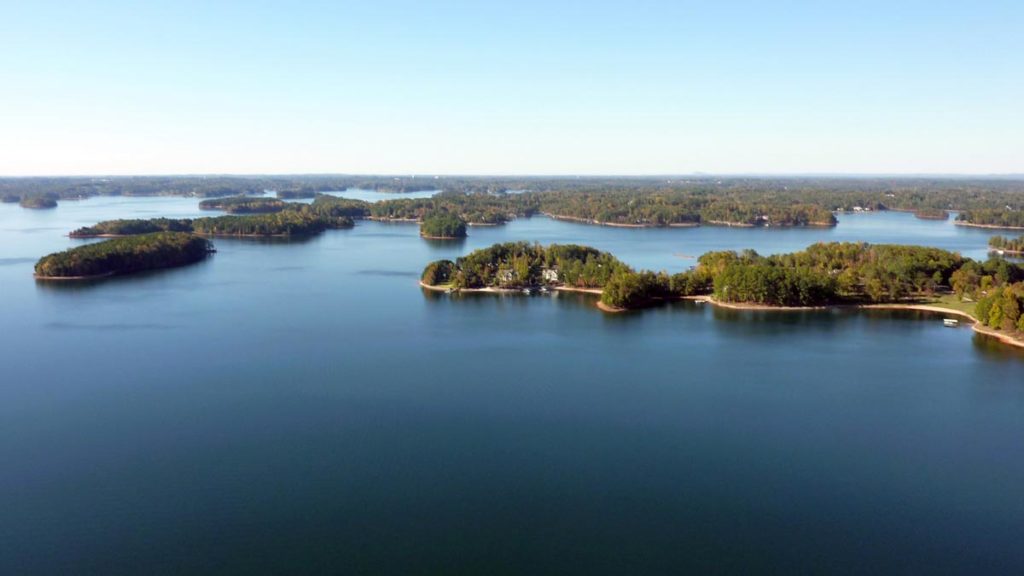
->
<box><xmin>0</xmin><ymin>191</ymin><xmax>1024</xmax><ymax>574</ymax></box>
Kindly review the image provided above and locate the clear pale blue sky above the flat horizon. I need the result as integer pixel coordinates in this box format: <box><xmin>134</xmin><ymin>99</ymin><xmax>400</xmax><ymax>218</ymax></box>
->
<box><xmin>0</xmin><ymin>0</ymin><xmax>1024</xmax><ymax>175</ymax></box>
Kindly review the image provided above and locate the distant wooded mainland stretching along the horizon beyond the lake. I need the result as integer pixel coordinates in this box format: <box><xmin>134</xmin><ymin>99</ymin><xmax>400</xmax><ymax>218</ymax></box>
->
<box><xmin>6</xmin><ymin>175</ymin><xmax>1024</xmax><ymax>227</ymax></box>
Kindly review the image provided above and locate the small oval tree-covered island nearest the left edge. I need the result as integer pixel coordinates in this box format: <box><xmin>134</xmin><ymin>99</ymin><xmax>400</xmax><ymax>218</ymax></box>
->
<box><xmin>36</xmin><ymin>232</ymin><xmax>213</xmax><ymax>279</ymax></box>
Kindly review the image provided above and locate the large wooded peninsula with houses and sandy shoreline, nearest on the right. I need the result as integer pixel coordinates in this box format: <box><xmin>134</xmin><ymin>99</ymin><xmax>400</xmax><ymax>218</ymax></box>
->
<box><xmin>421</xmin><ymin>242</ymin><xmax>1024</xmax><ymax>345</ymax></box>
